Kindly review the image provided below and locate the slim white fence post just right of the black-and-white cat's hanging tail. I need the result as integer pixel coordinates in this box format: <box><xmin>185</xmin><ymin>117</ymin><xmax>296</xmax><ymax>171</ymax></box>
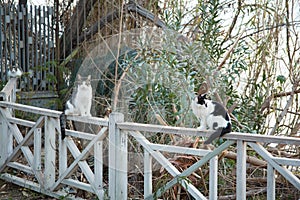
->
<box><xmin>236</xmin><ymin>140</ymin><xmax>247</xmax><ymax>200</ymax></box>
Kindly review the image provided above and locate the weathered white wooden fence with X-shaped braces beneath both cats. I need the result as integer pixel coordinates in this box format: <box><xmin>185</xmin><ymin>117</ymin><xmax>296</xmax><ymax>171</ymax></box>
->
<box><xmin>0</xmin><ymin>79</ymin><xmax>300</xmax><ymax>200</ymax></box>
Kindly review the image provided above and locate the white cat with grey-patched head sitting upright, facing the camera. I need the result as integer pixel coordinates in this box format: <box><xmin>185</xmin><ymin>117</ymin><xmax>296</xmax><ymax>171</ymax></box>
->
<box><xmin>65</xmin><ymin>74</ymin><xmax>93</xmax><ymax>116</ymax></box>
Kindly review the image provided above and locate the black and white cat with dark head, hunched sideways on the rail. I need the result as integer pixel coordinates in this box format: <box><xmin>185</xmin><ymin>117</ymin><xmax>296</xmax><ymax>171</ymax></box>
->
<box><xmin>191</xmin><ymin>83</ymin><xmax>232</xmax><ymax>144</ymax></box>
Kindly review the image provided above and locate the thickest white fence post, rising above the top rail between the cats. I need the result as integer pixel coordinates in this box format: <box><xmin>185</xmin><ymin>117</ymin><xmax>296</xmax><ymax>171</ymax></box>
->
<box><xmin>108</xmin><ymin>112</ymin><xmax>128</xmax><ymax>200</ymax></box>
